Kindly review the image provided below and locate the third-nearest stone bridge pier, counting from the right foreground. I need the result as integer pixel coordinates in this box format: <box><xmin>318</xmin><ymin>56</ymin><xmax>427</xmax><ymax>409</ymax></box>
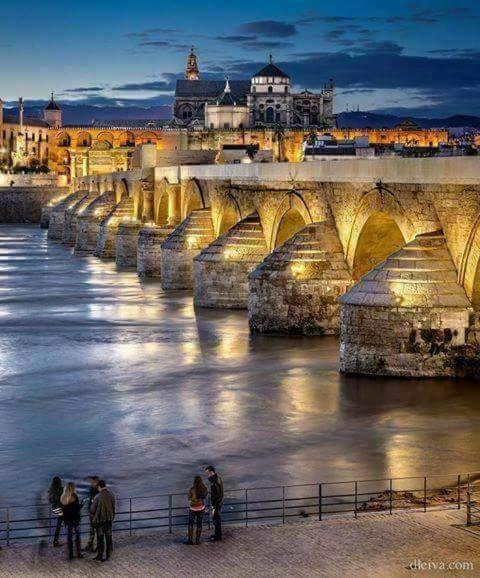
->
<box><xmin>194</xmin><ymin>213</ymin><xmax>268</xmax><ymax>309</ymax></box>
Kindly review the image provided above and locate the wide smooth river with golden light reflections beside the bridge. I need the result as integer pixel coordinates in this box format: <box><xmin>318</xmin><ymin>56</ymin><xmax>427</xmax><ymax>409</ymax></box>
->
<box><xmin>0</xmin><ymin>225</ymin><xmax>480</xmax><ymax>504</ymax></box>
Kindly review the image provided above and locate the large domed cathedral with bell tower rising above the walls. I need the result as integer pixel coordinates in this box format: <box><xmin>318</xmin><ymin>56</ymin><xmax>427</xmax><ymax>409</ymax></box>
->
<box><xmin>173</xmin><ymin>48</ymin><xmax>336</xmax><ymax>130</ymax></box>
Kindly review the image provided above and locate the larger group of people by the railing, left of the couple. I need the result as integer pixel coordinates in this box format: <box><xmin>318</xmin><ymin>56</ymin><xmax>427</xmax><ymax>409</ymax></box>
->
<box><xmin>48</xmin><ymin>476</ymin><xmax>115</xmax><ymax>562</ymax></box>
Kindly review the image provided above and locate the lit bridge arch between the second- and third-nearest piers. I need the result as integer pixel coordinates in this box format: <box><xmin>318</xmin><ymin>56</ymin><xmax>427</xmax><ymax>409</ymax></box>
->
<box><xmin>270</xmin><ymin>190</ymin><xmax>313</xmax><ymax>251</ymax></box>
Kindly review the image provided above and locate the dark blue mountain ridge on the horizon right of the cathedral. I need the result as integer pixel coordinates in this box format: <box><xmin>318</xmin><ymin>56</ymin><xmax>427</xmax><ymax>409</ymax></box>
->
<box><xmin>337</xmin><ymin>112</ymin><xmax>480</xmax><ymax>128</ymax></box>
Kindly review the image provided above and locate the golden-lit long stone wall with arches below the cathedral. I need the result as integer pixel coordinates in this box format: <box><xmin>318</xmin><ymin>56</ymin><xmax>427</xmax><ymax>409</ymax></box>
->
<box><xmin>48</xmin><ymin>126</ymin><xmax>448</xmax><ymax>177</ymax></box>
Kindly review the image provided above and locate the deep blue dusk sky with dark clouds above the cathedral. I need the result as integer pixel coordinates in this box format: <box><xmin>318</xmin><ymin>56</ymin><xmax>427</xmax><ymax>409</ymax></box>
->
<box><xmin>0</xmin><ymin>0</ymin><xmax>480</xmax><ymax>116</ymax></box>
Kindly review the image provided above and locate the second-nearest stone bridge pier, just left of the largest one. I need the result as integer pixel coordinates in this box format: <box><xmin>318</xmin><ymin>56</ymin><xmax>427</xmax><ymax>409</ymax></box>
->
<box><xmin>248</xmin><ymin>221</ymin><xmax>353</xmax><ymax>335</ymax></box>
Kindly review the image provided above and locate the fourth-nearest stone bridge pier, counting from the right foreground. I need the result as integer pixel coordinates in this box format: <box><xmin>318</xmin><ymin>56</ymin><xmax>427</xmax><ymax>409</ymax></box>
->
<box><xmin>161</xmin><ymin>209</ymin><xmax>215</xmax><ymax>289</ymax></box>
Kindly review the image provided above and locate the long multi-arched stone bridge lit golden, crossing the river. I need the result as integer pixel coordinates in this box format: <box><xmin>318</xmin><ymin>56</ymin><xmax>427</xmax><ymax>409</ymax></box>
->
<box><xmin>45</xmin><ymin>157</ymin><xmax>480</xmax><ymax>375</ymax></box>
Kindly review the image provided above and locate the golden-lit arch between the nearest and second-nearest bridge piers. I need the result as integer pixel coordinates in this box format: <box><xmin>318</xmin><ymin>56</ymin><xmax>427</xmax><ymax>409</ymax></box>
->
<box><xmin>346</xmin><ymin>187</ymin><xmax>415</xmax><ymax>279</ymax></box>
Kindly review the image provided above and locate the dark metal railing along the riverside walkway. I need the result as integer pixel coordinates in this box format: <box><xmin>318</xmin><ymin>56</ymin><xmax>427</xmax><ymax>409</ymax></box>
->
<box><xmin>0</xmin><ymin>473</ymin><xmax>480</xmax><ymax>546</ymax></box>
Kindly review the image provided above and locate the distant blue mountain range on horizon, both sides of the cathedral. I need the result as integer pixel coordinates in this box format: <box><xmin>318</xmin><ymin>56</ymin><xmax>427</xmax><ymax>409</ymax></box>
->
<box><xmin>8</xmin><ymin>103</ymin><xmax>480</xmax><ymax>128</ymax></box>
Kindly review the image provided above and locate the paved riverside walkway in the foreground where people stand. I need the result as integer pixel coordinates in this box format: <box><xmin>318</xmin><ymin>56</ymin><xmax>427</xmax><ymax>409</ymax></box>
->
<box><xmin>0</xmin><ymin>510</ymin><xmax>480</xmax><ymax>578</ymax></box>
